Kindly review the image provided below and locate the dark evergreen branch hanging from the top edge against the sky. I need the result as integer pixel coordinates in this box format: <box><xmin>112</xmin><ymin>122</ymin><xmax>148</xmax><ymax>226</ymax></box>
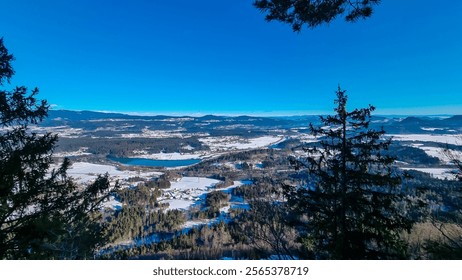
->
<box><xmin>254</xmin><ymin>0</ymin><xmax>380</xmax><ymax>32</ymax></box>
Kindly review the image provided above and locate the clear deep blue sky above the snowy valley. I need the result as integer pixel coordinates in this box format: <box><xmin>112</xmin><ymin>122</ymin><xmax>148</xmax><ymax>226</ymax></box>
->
<box><xmin>0</xmin><ymin>0</ymin><xmax>462</xmax><ymax>115</ymax></box>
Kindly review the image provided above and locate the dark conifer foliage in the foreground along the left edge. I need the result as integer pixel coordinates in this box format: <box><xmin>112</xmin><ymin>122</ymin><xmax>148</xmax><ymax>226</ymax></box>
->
<box><xmin>0</xmin><ymin>38</ymin><xmax>110</xmax><ymax>259</ymax></box>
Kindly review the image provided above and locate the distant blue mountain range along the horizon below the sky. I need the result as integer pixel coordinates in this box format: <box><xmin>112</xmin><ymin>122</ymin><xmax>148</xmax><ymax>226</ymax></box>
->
<box><xmin>41</xmin><ymin>110</ymin><xmax>462</xmax><ymax>134</ymax></box>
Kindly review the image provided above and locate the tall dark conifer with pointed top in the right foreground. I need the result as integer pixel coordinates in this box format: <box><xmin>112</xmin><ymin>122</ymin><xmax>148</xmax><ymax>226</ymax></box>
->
<box><xmin>286</xmin><ymin>88</ymin><xmax>412</xmax><ymax>259</ymax></box>
